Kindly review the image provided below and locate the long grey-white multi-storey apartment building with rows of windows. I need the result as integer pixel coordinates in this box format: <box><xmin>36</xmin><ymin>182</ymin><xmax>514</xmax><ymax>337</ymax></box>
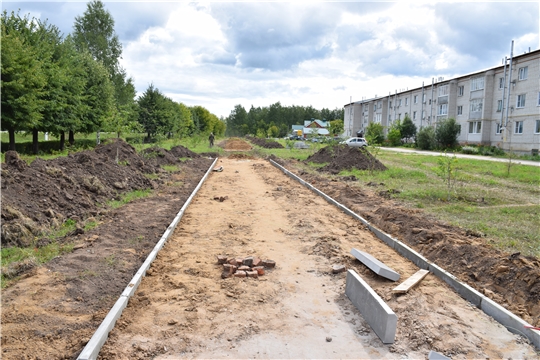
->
<box><xmin>344</xmin><ymin>50</ymin><xmax>540</xmax><ymax>153</ymax></box>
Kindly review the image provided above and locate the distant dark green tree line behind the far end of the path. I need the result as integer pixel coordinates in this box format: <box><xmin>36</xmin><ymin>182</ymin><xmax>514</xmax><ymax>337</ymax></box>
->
<box><xmin>225</xmin><ymin>102</ymin><xmax>344</xmax><ymax>137</ymax></box>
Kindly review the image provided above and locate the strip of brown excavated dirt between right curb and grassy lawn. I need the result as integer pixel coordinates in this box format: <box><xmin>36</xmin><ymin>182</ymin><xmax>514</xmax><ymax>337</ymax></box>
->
<box><xmin>282</xmin><ymin>161</ymin><xmax>540</xmax><ymax>326</ymax></box>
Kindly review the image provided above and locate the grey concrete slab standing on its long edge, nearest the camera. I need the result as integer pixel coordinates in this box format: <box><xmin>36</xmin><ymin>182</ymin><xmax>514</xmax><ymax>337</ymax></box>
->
<box><xmin>345</xmin><ymin>270</ymin><xmax>397</xmax><ymax>344</ymax></box>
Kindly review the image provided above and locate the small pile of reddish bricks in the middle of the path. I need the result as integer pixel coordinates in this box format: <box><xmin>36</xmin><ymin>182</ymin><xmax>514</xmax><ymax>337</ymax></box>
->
<box><xmin>217</xmin><ymin>255</ymin><xmax>276</xmax><ymax>279</ymax></box>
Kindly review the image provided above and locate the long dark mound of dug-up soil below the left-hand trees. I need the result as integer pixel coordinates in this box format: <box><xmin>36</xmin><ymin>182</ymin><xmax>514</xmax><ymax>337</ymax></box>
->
<box><xmin>1</xmin><ymin>140</ymin><xmax>194</xmax><ymax>246</ymax></box>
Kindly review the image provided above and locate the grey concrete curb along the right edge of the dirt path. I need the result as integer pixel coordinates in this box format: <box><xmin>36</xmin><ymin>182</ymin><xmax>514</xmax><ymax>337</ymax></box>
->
<box><xmin>269</xmin><ymin>160</ymin><xmax>540</xmax><ymax>349</ymax></box>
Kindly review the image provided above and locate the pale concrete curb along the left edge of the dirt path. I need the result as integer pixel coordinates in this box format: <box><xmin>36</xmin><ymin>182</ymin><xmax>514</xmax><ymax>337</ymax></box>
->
<box><xmin>77</xmin><ymin>158</ymin><xmax>218</xmax><ymax>360</ymax></box>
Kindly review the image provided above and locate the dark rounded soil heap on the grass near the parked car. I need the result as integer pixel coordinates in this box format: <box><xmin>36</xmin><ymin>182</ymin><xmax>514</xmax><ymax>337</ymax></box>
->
<box><xmin>306</xmin><ymin>144</ymin><xmax>386</xmax><ymax>175</ymax></box>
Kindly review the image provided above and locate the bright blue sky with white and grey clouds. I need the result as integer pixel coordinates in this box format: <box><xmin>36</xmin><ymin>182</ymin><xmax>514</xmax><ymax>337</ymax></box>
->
<box><xmin>2</xmin><ymin>0</ymin><xmax>540</xmax><ymax>116</ymax></box>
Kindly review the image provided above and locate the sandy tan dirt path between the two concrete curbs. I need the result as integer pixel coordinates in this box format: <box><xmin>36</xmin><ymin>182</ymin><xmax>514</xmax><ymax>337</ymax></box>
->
<box><xmin>101</xmin><ymin>159</ymin><xmax>537</xmax><ymax>359</ymax></box>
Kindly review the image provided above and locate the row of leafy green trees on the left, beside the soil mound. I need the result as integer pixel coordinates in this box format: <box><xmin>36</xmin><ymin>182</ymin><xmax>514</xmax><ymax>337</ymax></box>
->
<box><xmin>1</xmin><ymin>0</ymin><xmax>225</xmax><ymax>153</ymax></box>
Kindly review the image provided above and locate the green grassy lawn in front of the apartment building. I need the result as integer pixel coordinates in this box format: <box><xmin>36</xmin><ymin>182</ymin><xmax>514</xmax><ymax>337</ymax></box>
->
<box><xmin>340</xmin><ymin>152</ymin><xmax>540</xmax><ymax>257</ymax></box>
